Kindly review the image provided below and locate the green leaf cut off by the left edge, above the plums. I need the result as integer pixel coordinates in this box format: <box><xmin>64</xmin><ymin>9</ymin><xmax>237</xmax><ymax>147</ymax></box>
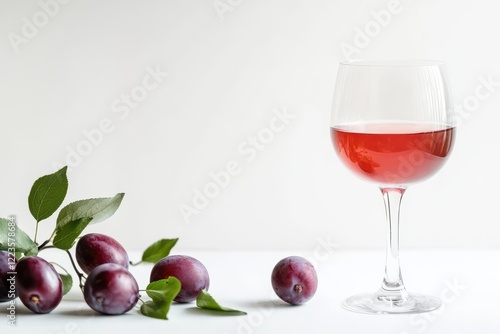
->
<box><xmin>0</xmin><ymin>218</ymin><xmax>38</xmax><ymax>258</ymax></box>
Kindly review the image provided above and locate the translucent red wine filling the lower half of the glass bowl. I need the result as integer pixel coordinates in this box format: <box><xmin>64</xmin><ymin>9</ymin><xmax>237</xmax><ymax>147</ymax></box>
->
<box><xmin>331</xmin><ymin>123</ymin><xmax>455</xmax><ymax>186</ymax></box>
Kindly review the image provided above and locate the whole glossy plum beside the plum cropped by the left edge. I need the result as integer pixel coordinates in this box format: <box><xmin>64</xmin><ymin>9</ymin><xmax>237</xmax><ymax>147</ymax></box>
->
<box><xmin>16</xmin><ymin>256</ymin><xmax>63</xmax><ymax>313</ymax></box>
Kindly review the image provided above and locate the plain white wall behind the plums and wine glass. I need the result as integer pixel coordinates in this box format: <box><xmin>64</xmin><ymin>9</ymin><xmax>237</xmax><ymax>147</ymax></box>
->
<box><xmin>0</xmin><ymin>0</ymin><xmax>500</xmax><ymax>250</ymax></box>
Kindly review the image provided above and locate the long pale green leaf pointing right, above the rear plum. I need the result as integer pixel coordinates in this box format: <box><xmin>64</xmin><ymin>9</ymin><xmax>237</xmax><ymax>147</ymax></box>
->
<box><xmin>56</xmin><ymin>193</ymin><xmax>125</xmax><ymax>229</ymax></box>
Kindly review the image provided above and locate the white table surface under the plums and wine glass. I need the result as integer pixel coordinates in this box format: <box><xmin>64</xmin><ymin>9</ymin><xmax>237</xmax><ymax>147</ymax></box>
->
<box><xmin>0</xmin><ymin>249</ymin><xmax>500</xmax><ymax>334</ymax></box>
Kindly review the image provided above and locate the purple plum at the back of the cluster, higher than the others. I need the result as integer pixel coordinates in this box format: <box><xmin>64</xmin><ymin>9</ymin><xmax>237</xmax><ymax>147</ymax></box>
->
<box><xmin>75</xmin><ymin>233</ymin><xmax>129</xmax><ymax>274</ymax></box>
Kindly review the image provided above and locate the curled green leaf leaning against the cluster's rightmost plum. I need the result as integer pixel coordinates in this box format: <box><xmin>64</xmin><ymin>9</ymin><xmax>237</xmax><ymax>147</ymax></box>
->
<box><xmin>141</xmin><ymin>276</ymin><xmax>181</xmax><ymax>320</ymax></box>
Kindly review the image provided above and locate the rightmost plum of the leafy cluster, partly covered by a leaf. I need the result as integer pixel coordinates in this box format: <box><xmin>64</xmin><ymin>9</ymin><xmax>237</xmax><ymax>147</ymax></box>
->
<box><xmin>150</xmin><ymin>255</ymin><xmax>210</xmax><ymax>303</ymax></box>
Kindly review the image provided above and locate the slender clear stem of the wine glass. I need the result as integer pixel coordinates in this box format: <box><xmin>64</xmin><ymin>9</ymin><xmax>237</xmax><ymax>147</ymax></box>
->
<box><xmin>378</xmin><ymin>188</ymin><xmax>408</xmax><ymax>302</ymax></box>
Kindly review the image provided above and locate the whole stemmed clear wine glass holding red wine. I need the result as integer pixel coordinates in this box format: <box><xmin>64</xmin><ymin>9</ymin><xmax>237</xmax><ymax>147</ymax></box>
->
<box><xmin>330</xmin><ymin>60</ymin><xmax>455</xmax><ymax>314</ymax></box>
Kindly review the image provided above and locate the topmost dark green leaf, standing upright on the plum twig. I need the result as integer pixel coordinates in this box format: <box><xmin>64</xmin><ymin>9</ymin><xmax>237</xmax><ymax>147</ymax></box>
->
<box><xmin>28</xmin><ymin>166</ymin><xmax>68</xmax><ymax>223</ymax></box>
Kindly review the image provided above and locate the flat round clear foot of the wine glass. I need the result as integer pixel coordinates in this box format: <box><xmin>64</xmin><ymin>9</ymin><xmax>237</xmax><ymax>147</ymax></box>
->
<box><xmin>342</xmin><ymin>293</ymin><xmax>441</xmax><ymax>314</ymax></box>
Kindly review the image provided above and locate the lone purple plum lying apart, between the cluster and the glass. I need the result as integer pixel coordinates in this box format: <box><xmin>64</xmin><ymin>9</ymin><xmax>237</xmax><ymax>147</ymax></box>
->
<box><xmin>271</xmin><ymin>256</ymin><xmax>318</xmax><ymax>305</ymax></box>
